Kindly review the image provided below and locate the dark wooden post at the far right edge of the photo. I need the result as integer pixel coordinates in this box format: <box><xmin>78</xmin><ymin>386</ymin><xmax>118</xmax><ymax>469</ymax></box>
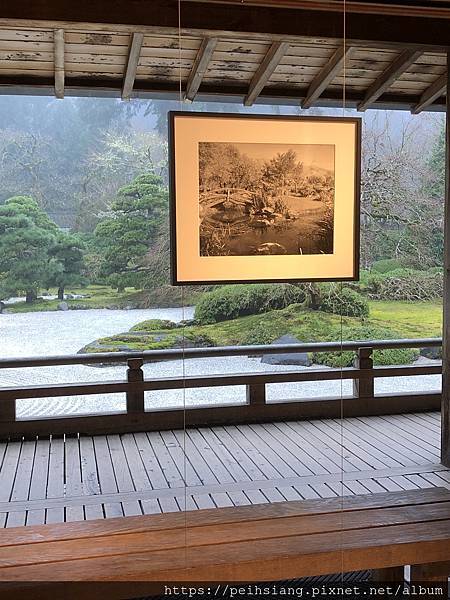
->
<box><xmin>441</xmin><ymin>52</ymin><xmax>450</xmax><ymax>467</ymax></box>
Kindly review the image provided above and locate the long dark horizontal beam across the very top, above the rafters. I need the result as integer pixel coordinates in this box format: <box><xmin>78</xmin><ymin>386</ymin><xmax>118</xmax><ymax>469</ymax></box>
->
<box><xmin>0</xmin><ymin>0</ymin><xmax>450</xmax><ymax>51</ymax></box>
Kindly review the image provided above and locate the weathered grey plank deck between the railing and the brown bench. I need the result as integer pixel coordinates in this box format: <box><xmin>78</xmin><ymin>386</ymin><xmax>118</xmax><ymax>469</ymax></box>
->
<box><xmin>0</xmin><ymin>413</ymin><xmax>450</xmax><ymax>527</ymax></box>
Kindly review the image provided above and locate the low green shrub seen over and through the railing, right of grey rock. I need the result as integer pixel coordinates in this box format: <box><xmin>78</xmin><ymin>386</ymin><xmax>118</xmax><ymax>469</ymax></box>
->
<box><xmin>313</xmin><ymin>325</ymin><xmax>419</xmax><ymax>368</ymax></box>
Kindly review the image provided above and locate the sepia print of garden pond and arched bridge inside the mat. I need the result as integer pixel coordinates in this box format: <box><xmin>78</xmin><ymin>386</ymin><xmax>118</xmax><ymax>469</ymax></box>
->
<box><xmin>198</xmin><ymin>142</ymin><xmax>335</xmax><ymax>256</ymax></box>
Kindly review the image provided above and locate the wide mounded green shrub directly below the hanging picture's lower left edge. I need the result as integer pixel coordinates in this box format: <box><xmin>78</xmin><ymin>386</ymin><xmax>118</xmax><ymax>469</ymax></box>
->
<box><xmin>195</xmin><ymin>284</ymin><xmax>305</xmax><ymax>325</ymax></box>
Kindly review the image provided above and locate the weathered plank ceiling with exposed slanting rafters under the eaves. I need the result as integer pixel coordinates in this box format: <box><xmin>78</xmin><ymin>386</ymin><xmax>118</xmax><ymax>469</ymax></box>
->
<box><xmin>0</xmin><ymin>0</ymin><xmax>450</xmax><ymax>113</ymax></box>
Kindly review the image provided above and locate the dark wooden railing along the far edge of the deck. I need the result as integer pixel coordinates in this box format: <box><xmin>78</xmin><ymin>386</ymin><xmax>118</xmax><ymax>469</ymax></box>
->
<box><xmin>0</xmin><ymin>338</ymin><xmax>442</xmax><ymax>439</ymax></box>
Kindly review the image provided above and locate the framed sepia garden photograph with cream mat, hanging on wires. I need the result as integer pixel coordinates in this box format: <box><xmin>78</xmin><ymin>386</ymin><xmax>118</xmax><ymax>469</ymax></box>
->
<box><xmin>169</xmin><ymin>112</ymin><xmax>361</xmax><ymax>285</ymax></box>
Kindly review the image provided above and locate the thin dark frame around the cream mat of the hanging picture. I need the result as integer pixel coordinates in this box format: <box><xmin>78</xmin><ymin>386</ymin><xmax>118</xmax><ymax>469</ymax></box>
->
<box><xmin>168</xmin><ymin>111</ymin><xmax>362</xmax><ymax>286</ymax></box>
